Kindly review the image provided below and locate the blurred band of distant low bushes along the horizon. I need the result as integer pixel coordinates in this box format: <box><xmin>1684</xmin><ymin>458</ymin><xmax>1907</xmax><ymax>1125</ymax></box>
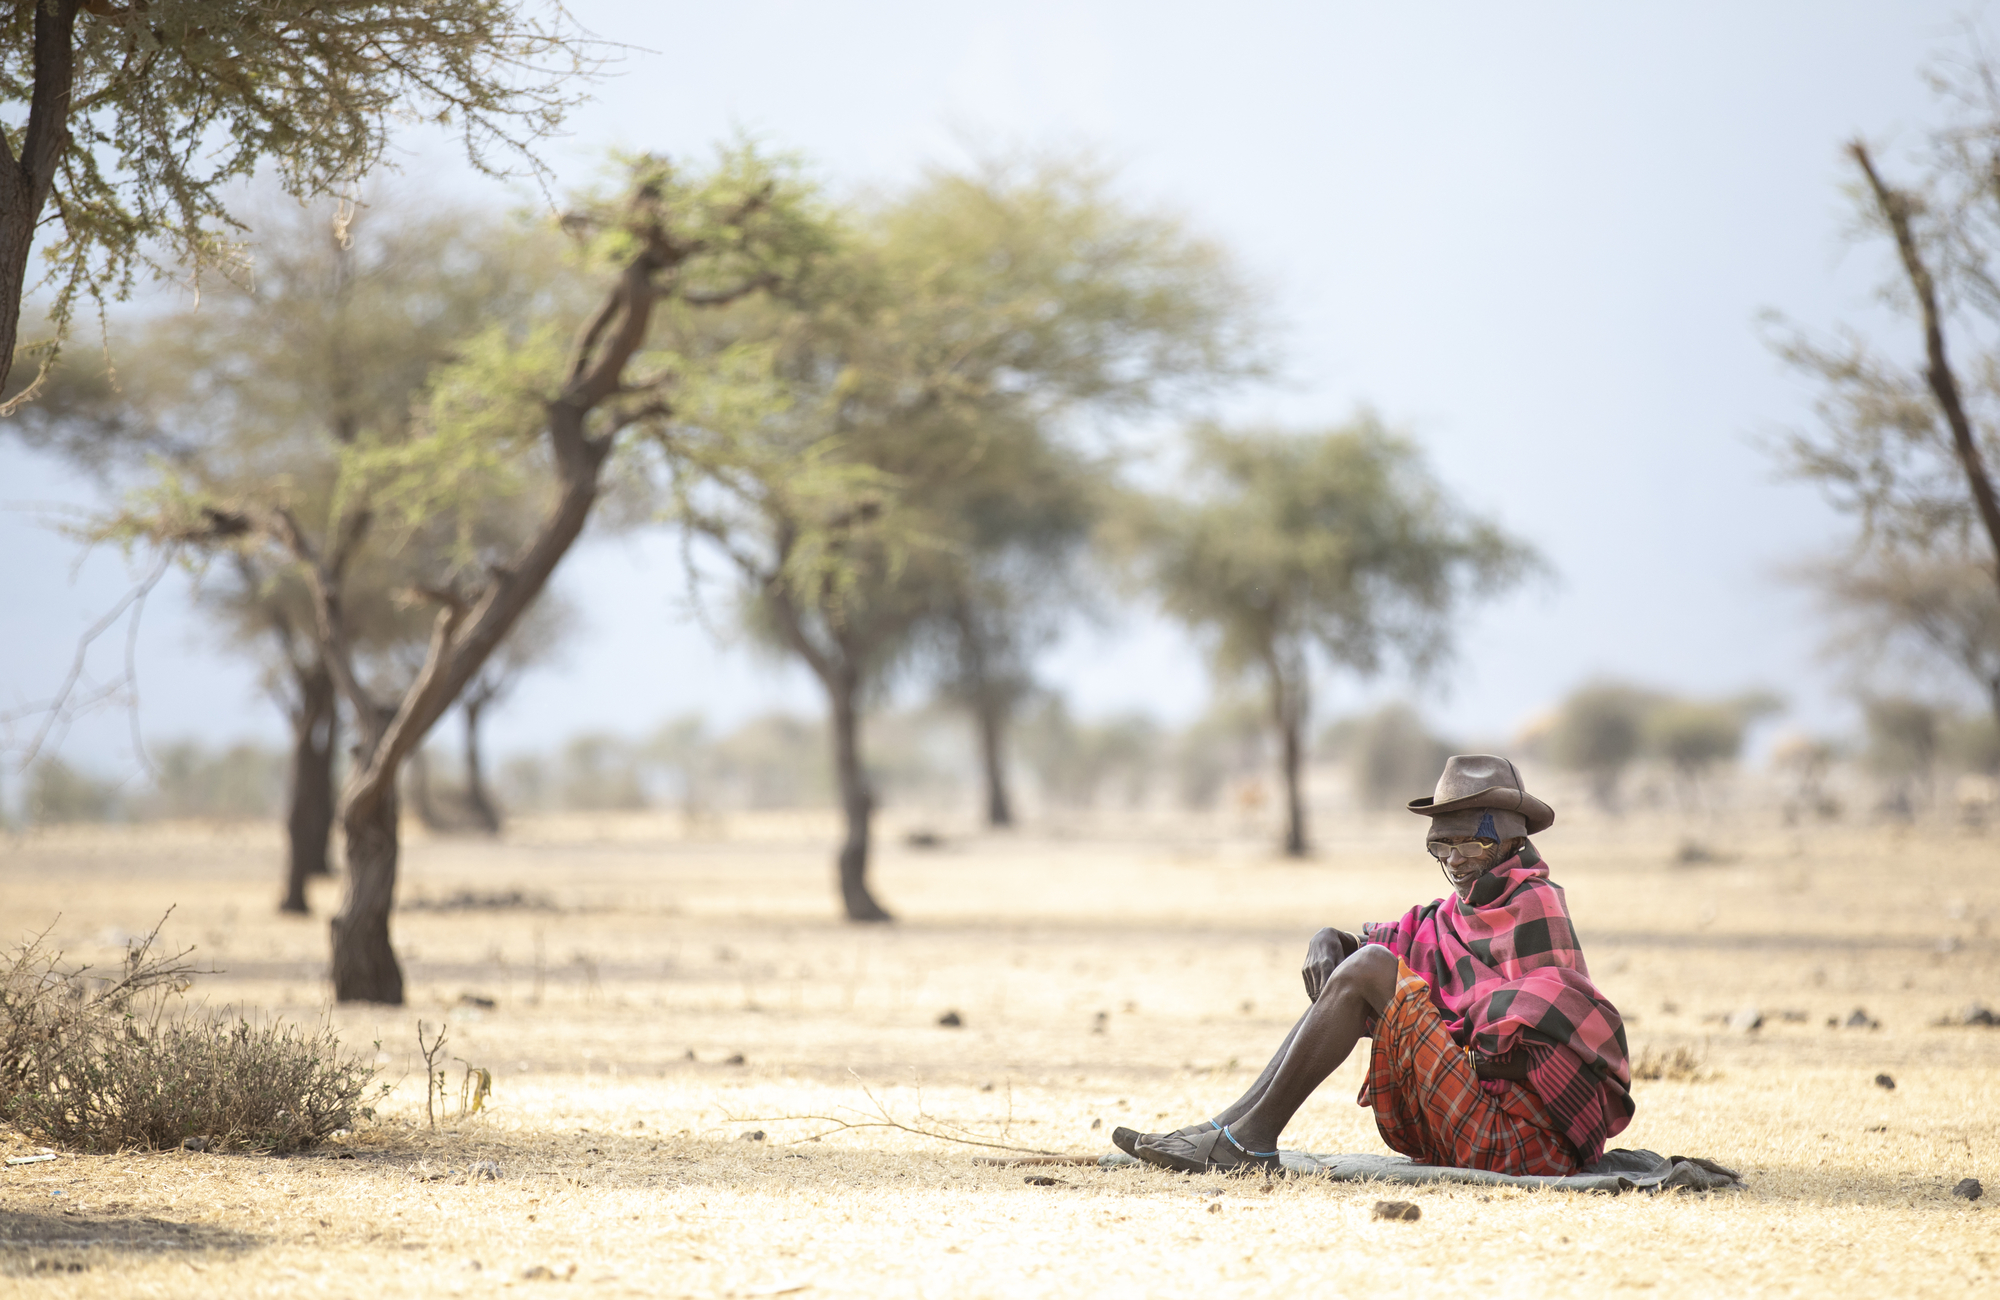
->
<box><xmin>20</xmin><ymin>682</ymin><xmax>2000</xmax><ymax>830</ymax></box>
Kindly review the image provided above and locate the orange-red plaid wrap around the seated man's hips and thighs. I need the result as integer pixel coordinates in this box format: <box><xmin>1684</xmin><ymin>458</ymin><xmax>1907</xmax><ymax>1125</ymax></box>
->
<box><xmin>1356</xmin><ymin>962</ymin><xmax>1576</xmax><ymax>1176</ymax></box>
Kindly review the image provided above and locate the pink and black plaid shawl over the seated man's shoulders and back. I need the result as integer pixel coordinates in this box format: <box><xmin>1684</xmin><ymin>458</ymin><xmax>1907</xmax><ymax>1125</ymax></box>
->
<box><xmin>1362</xmin><ymin>844</ymin><xmax>1634</xmax><ymax>1164</ymax></box>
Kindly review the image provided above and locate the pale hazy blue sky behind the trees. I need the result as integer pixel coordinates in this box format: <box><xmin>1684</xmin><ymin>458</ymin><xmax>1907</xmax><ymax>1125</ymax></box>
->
<box><xmin>0</xmin><ymin>0</ymin><xmax>1980</xmax><ymax>770</ymax></box>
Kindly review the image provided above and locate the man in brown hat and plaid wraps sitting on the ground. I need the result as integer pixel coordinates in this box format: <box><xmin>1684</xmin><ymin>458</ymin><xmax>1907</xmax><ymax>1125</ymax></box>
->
<box><xmin>1112</xmin><ymin>754</ymin><xmax>1632</xmax><ymax>1176</ymax></box>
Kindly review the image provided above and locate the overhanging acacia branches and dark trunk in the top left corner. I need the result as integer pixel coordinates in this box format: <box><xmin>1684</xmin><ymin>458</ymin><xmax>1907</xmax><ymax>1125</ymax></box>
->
<box><xmin>0</xmin><ymin>0</ymin><xmax>594</xmax><ymax>412</ymax></box>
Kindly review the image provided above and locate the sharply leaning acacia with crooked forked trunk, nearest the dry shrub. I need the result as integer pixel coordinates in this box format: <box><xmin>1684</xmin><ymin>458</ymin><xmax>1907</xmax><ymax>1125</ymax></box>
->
<box><xmin>122</xmin><ymin>150</ymin><xmax>822</xmax><ymax>1002</ymax></box>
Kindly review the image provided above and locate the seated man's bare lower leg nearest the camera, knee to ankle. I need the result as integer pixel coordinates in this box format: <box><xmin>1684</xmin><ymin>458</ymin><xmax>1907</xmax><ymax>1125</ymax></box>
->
<box><xmin>1214</xmin><ymin>944</ymin><xmax>1396</xmax><ymax>1152</ymax></box>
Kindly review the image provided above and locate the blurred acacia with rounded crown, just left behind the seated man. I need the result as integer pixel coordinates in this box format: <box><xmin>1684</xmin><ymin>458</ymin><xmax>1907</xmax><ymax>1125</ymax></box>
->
<box><xmin>1134</xmin><ymin>412</ymin><xmax>1536</xmax><ymax>856</ymax></box>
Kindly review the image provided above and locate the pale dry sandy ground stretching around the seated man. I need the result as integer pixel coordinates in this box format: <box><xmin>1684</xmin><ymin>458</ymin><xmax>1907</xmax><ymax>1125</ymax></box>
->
<box><xmin>0</xmin><ymin>816</ymin><xmax>2000</xmax><ymax>1296</ymax></box>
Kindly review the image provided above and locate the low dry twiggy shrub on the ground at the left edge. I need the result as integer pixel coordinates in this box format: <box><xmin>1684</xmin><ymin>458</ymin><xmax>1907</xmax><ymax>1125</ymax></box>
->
<box><xmin>0</xmin><ymin>918</ymin><xmax>374</xmax><ymax>1152</ymax></box>
